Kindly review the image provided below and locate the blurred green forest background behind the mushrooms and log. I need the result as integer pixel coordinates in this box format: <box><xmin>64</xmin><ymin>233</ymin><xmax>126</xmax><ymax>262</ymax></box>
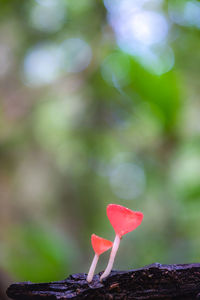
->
<box><xmin>0</xmin><ymin>0</ymin><xmax>200</xmax><ymax>282</ymax></box>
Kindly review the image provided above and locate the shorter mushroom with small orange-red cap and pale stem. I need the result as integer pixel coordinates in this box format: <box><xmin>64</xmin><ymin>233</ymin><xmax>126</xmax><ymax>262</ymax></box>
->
<box><xmin>87</xmin><ymin>234</ymin><xmax>113</xmax><ymax>283</ymax></box>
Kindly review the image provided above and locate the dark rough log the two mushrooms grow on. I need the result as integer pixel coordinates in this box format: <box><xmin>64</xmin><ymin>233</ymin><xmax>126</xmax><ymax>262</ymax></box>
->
<box><xmin>7</xmin><ymin>263</ymin><xmax>200</xmax><ymax>300</ymax></box>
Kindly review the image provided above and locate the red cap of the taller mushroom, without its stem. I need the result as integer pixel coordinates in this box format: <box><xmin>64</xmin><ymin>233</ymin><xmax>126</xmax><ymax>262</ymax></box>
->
<box><xmin>107</xmin><ymin>204</ymin><xmax>143</xmax><ymax>237</ymax></box>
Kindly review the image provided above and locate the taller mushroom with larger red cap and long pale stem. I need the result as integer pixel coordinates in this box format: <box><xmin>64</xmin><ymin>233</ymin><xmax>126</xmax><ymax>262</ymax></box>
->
<box><xmin>100</xmin><ymin>204</ymin><xmax>143</xmax><ymax>281</ymax></box>
